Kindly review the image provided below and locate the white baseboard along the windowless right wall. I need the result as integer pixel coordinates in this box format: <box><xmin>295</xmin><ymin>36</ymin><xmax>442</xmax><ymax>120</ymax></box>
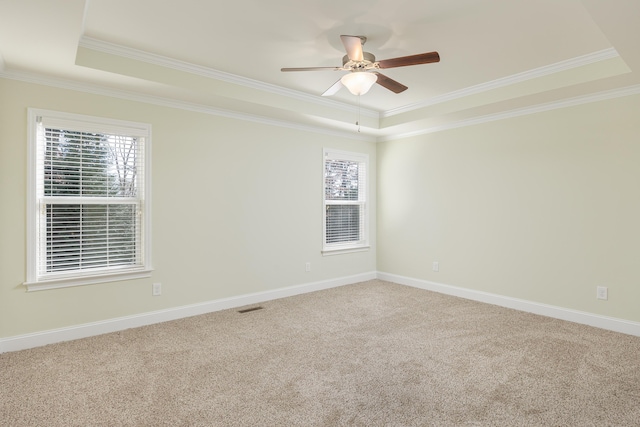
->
<box><xmin>377</xmin><ymin>272</ymin><xmax>640</xmax><ymax>336</ymax></box>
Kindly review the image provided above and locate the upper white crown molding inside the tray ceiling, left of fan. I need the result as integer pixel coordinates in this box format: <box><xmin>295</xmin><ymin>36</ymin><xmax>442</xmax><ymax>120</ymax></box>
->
<box><xmin>78</xmin><ymin>36</ymin><xmax>380</xmax><ymax>120</ymax></box>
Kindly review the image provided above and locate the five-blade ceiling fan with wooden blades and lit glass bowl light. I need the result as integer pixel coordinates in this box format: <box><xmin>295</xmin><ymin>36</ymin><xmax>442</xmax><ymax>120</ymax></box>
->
<box><xmin>281</xmin><ymin>36</ymin><xmax>440</xmax><ymax>96</ymax></box>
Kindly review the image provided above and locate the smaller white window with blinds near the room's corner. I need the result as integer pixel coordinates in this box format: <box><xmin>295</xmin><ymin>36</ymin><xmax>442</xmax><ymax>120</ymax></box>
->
<box><xmin>323</xmin><ymin>149</ymin><xmax>369</xmax><ymax>253</ymax></box>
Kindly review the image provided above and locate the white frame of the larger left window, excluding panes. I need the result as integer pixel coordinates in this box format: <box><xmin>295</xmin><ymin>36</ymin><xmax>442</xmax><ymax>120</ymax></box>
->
<box><xmin>24</xmin><ymin>108</ymin><xmax>153</xmax><ymax>291</ymax></box>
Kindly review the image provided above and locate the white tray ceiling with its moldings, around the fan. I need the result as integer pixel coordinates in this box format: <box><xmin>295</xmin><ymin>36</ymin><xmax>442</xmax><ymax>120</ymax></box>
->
<box><xmin>0</xmin><ymin>0</ymin><xmax>640</xmax><ymax>139</ymax></box>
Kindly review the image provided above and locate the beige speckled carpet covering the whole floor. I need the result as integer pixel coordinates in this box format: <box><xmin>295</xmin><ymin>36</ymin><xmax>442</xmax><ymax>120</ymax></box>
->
<box><xmin>0</xmin><ymin>280</ymin><xmax>640</xmax><ymax>426</ymax></box>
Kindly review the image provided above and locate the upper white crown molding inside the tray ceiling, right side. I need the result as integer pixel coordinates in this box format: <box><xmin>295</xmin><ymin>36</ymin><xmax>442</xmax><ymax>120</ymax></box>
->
<box><xmin>380</xmin><ymin>47</ymin><xmax>620</xmax><ymax>118</ymax></box>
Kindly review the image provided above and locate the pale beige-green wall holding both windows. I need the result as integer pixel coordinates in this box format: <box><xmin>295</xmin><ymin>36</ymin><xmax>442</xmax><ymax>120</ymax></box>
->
<box><xmin>0</xmin><ymin>79</ymin><xmax>376</xmax><ymax>338</ymax></box>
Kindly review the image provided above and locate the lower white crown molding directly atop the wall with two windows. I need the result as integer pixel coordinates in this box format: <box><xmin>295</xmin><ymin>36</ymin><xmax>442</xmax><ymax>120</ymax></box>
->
<box><xmin>0</xmin><ymin>71</ymin><xmax>376</xmax><ymax>142</ymax></box>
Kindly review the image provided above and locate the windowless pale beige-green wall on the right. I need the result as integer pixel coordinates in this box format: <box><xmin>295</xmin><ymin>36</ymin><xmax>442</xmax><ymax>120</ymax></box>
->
<box><xmin>377</xmin><ymin>96</ymin><xmax>640</xmax><ymax>321</ymax></box>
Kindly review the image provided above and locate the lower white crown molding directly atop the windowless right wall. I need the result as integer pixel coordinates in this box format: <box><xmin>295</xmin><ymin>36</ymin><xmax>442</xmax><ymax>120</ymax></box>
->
<box><xmin>378</xmin><ymin>84</ymin><xmax>640</xmax><ymax>142</ymax></box>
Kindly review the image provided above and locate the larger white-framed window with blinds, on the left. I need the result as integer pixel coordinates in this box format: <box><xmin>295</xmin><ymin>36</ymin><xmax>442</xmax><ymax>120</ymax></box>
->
<box><xmin>26</xmin><ymin>109</ymin><xmax>151</xmax><ymax>290</ymax></box>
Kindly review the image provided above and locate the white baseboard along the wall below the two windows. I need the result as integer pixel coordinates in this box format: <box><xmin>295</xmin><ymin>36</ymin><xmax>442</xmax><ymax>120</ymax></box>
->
<box><xmin>0</xmin><ymin>272</ymin><xmax>376</xmax><ymax>353</ymax></box>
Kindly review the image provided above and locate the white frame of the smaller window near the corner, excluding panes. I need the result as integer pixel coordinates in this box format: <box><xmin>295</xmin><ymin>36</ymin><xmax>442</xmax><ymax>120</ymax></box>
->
<box><xmin>322</xmin><ymin>148</ymin><xmax>370</xmax><ymax>255</ymax></box>
